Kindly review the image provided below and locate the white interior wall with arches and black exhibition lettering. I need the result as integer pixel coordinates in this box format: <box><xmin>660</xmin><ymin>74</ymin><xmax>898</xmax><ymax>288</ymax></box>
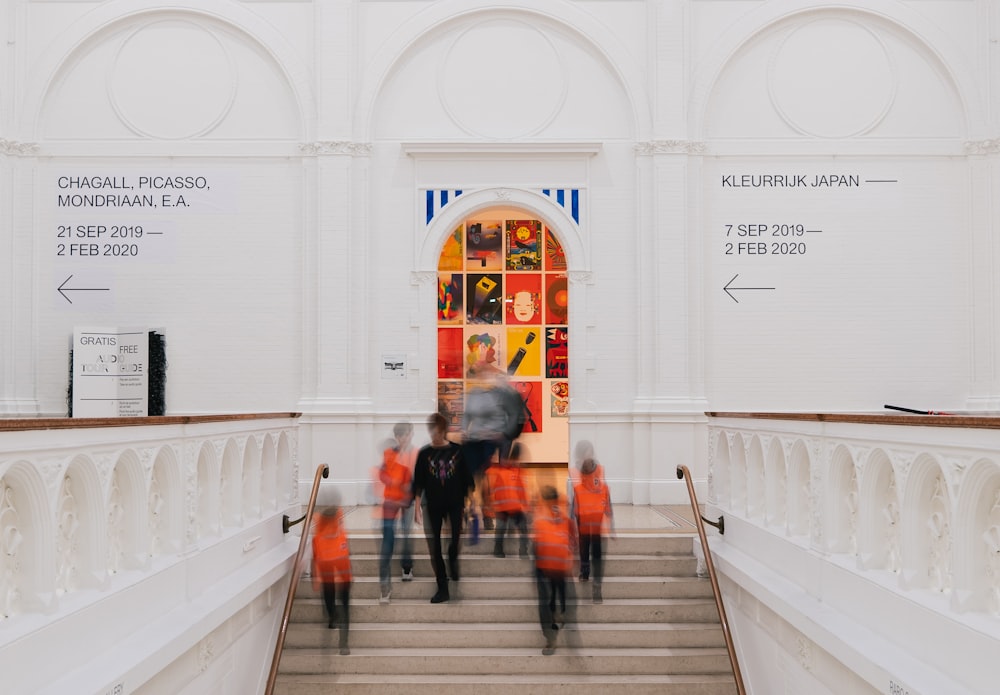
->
<box><xmin>0</xmin><ymin>0</ymin><xmax>1000</xmax><ymax>682</ymax></box>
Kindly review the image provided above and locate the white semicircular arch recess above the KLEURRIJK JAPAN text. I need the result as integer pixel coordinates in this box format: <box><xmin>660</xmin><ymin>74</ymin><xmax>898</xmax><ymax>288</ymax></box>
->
<box><xmin>688</xmin><ymin>0</ymin><xmax>988</xmax><ymax>139</ymax></box>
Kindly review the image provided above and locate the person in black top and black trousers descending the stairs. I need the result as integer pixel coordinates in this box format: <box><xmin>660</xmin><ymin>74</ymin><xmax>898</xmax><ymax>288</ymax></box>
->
<box><xmin>413</xmin><ymin>413</ymin><xmax>475</xmax><ymax>603</ymax></box>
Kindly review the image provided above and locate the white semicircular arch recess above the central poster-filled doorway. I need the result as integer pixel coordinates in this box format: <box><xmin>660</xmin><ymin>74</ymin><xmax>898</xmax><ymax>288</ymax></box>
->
<box><xmin>355</xmin><ymin>0</ymin><xmax>652</xmax><ymax>140</ymax></box>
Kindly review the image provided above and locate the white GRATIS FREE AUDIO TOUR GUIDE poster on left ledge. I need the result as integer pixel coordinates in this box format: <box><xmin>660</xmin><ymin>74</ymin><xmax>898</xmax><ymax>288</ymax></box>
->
<box><xmin>73</xmin><ymin>328</ymin><xmax>149</xmax><ymax>417</ymax></box>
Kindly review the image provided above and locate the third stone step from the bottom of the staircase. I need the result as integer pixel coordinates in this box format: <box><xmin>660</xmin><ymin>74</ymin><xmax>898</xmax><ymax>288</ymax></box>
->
<box><xmin>285</xmin><ymin>620</ymin><xmax>725</xmax><ymax>650</ymax></box>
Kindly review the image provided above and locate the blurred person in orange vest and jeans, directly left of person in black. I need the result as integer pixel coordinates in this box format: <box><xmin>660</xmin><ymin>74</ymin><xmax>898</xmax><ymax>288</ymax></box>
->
<box><xmin>378</xmin><ymin>423</ymin><xmax>413</xmax><ymax>603</ymax></box>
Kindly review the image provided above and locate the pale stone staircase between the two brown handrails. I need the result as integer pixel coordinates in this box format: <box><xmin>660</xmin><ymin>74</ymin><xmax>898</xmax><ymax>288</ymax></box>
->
<box><xmin>275</xmin><ymin>527</ymin><xmax>736</xmax><ymax>695</ymax></box>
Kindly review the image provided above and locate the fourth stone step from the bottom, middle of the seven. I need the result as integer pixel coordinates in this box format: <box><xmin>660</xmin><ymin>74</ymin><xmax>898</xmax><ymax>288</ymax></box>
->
<box><xmin>290</xmin><ymin>596</ymin><xmax>719</xmax><ymax>625</ymax></box>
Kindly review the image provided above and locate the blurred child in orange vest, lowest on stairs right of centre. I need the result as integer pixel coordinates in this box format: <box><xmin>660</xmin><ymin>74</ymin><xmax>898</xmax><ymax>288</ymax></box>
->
<box><xmin>532</xmin><ymin>485</ymin><xmax>574</xmax><ymax>656</ymax></box>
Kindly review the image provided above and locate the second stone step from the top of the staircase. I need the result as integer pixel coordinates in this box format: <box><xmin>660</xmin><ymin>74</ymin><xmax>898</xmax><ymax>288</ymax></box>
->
<box><xmin>332</xmin><ymin>550</ymin><xmax>698</xmax><ymax>577</ymax></box>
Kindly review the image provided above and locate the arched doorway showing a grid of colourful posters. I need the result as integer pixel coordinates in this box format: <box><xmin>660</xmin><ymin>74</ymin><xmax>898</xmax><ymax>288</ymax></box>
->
<box><xmin>437</xmin><ymin>208</ymin><xmax>569</xmax><ymax>468</ymax></box>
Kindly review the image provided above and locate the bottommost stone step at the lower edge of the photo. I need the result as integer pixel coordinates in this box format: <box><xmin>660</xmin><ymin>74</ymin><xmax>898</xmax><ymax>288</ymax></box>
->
<box><xmin>274</xmin><ymin>676</ymin><xmax>736</xmax><ymax>695</ymax></box>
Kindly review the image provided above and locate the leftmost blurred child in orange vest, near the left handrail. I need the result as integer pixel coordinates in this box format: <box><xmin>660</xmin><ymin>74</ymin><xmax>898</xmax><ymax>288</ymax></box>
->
<box><xmin>312</xmin><ymin>505</ymin><xmax>352</xmax><ymax>655</ymax></box>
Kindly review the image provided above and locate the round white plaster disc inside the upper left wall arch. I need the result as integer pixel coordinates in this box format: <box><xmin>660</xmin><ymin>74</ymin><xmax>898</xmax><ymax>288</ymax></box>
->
<box><xmin>107</xmin><ymin>19</ymin><xmax>238</xmax><ymax>140</ymax></box>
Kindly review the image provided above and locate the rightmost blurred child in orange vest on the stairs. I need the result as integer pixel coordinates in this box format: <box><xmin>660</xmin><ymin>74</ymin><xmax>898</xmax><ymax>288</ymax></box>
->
<box><xmin>572</xmin><ymin>441</ymin><xmax>614</xmax><ymax>603</ymax></box>
